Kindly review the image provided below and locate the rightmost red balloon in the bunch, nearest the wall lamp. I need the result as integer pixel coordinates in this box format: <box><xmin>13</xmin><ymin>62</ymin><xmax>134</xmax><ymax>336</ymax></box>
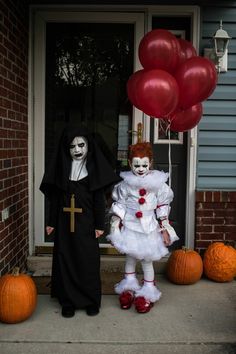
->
<box><xmin>174</xmin><ymin>56</ymin><xmax>217</xmax><ymax>109</ymax></box>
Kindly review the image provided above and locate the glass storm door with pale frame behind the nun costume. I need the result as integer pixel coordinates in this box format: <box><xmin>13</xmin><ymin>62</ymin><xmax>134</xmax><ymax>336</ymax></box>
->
<box><xmin>32</xmin><ymin>11</ymin><xmax>147</xmax><ymax>247</ymax></box>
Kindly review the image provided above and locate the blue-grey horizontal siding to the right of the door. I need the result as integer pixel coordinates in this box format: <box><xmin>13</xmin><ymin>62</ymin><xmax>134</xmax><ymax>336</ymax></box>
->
<box><xmin>197</xmin><ymin>1</ymin><xmax>236</xmax><ymax>190</ymax></box>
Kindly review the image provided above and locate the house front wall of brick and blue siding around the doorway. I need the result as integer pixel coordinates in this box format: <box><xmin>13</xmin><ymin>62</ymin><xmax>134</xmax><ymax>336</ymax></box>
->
<box><xmin>0</xmin><ymin>0</ymin><xmax>236</xmax><ymax>274</ymax></box>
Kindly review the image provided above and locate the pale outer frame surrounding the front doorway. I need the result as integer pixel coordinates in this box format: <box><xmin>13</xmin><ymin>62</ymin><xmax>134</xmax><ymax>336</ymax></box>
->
<box><xmin>28</xmin><ymin>5</ymin><xmax>200</xmax><ymax>255</ymax></box>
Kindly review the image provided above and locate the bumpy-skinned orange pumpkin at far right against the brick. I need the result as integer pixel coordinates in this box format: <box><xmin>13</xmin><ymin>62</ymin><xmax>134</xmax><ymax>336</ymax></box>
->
<box><xmin>203</xmin><ymin>242</ymin><xmax>236</xmax><ymax>283</ymax></box>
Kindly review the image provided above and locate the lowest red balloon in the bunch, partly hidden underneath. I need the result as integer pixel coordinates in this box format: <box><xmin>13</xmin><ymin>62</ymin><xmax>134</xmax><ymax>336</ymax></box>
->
<box><xmin>170</xmin><ymin>103</ymin><xmax>202</xmax><ymax>132</ymax></box>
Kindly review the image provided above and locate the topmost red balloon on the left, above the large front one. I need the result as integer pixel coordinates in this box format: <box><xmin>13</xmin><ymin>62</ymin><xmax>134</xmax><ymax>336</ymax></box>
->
<box><xmin>139</xmin><ymin>29</ymin><xmax>180</xmax><ymax>73</ymax></box>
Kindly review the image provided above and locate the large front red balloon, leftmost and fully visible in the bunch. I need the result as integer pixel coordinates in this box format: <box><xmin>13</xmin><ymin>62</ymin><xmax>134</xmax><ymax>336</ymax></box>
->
<box><xmin>136</xmin><ymin>69</ymin><xmax>179</xmax><ymax>118</ymax></box>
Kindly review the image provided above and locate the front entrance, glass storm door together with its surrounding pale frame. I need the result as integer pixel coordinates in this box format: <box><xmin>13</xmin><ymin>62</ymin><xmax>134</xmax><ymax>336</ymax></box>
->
<box><xmin>29</xmin><ymin>6</ymin><xmax>200</xmax><ymax>253</ymax></box>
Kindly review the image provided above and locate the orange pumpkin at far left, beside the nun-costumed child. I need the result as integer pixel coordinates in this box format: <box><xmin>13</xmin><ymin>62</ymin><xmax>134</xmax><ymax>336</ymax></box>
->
<box><xmin>0</xmin><ymin>268</ymin><xmax>37</xmax><ymax>323</ymax></box>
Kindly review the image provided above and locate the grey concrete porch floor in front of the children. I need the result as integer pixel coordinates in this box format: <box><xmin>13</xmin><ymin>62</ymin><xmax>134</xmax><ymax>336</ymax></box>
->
<box><xmin>0</xmin><ymin>276</ymin><xmax>236</xmax><ymax>354</ymax></box>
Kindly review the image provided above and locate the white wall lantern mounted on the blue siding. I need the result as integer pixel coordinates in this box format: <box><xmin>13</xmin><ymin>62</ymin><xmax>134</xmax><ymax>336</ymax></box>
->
<box><xmin>204</xmin><ymin>20</ymin><xmax>231</xmax><ymax>73</ymax></box>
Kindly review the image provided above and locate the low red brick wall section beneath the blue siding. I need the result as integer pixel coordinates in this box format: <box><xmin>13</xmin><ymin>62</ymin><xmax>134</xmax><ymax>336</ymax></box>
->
<box><xmin>195</xmin><ymin>191</ymin><xmax>236</xmax><ymax>254</ymax></box>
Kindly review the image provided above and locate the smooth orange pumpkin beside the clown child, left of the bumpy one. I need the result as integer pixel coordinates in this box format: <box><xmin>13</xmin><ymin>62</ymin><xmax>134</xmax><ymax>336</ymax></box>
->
<box><xmin>166</xmin><ymin>247</ymin><xmax>203</xmax><ymax>285</ymax></box>
